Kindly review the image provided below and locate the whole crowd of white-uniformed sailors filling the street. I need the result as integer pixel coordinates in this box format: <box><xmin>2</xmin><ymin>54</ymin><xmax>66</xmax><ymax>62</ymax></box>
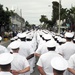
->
<box><xmin>0</xmin><ymin>29</ymin><xmax>75</xmax><ymax>75</ymax></box>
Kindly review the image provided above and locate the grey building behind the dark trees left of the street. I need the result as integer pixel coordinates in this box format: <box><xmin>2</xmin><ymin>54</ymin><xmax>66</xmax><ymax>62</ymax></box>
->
<box><xmin>10</xmin><ymin>13</ymin><xmax>25</xmax><ymax>31</ymax></box>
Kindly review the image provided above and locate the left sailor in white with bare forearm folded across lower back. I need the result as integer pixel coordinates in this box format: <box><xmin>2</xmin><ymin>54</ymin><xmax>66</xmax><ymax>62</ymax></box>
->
<box><xmin>7</xmin><ymin>41</ymin><xmax>30</xmax><ymax>75</ymax></box>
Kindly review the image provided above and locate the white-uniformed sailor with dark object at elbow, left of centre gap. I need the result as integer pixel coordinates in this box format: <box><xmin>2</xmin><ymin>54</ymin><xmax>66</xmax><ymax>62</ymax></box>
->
<box><xmin>19</xmin><ymin>33</ymin><xmax>34</xmax><ymax>73</ymax></box>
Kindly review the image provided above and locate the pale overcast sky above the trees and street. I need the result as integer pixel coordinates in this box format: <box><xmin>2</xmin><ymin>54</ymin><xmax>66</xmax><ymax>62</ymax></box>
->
<box><xmin>0</xmin><ymin>0</ymin><xmax>75</xmax><ymax>25</ymax></box>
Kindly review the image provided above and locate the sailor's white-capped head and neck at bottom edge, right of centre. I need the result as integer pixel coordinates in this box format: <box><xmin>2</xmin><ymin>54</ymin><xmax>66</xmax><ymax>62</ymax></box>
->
<box><xmin>50</xmin><ymin>57</ymin><xmax>68</xmax><ymax>75</ymax></box>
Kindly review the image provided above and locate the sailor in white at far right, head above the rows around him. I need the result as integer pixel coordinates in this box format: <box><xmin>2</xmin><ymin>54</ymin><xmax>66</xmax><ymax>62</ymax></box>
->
<box><xmin>55</xmin><ymin>32</ymin><xmax>75</xmax><ymax>60</ymax></box>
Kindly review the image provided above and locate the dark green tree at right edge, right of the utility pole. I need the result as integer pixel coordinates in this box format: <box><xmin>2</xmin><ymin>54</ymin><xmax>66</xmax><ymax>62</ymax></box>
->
<box><xmin>61</xmin><ymin>7</ymin><xmax>75</xmax><ymax>30</ymax></box>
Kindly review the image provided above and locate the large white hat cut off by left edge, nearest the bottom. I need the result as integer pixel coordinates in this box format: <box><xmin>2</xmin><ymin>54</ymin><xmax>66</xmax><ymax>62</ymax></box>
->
<box><xmin>0</xmin><ymin>53</ymin><xmax>13</xmax><ymax>65</ymax></box>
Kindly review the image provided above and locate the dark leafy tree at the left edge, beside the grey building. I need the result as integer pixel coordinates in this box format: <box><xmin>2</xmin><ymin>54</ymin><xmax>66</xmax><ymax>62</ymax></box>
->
<box><xmin>0</xmin><ymin>4</ymin><xmax>10</xmax><ymax>35</ymax></box>
